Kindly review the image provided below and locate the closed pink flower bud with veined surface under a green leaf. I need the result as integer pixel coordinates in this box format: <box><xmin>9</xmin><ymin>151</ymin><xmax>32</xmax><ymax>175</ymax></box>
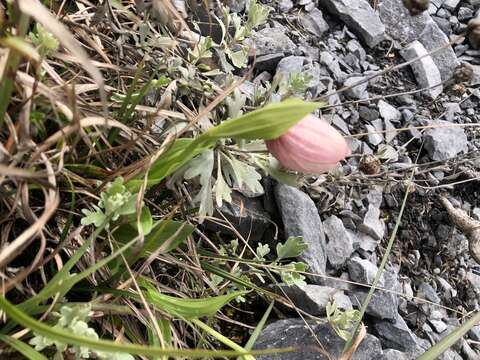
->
<box><xmin>266</xmin><ymin>114</ymin><xmax>351</xmax><ymax>174</ymax></box>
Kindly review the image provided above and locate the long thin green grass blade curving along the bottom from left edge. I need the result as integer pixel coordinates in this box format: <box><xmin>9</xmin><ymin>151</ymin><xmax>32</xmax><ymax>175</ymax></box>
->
<box><xmin>0</xmin><ymin>297</ymin><xmax>295</xmax><ymax>359</ymax></box>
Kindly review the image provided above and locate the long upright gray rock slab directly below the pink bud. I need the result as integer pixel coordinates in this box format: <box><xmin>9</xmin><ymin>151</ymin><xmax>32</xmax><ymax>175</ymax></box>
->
<box><xmin>274</xmin><ymin>184</ymin><xmax>327</xmax><ymax>284</ymax></box>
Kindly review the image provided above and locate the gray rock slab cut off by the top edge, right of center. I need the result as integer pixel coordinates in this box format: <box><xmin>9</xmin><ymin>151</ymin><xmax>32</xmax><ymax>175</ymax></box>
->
<box><xmin>319</xmin><ymin>0</ymin><xmax>385</xmax><ymax>47</ymax></box>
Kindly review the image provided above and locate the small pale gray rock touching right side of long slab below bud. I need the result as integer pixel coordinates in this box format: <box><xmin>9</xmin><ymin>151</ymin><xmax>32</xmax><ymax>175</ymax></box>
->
<box><xmin>323</xmin><ymin>215</ymin><xmax>354</xmax><ymax>269</ymax></box>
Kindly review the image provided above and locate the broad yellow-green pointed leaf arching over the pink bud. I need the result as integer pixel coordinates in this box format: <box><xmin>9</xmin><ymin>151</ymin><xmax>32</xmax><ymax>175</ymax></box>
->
<box><xmin>201</xmin><ymin>99</ymin><xmax>323</xmax><ymax>140</ymax></box>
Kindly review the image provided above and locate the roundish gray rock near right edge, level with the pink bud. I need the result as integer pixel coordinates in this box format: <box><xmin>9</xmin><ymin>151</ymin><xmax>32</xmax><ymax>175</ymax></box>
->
<box><xmin>425</xmin><ymin>120</ymin><xmax>468</xmax><ymax>161</ymax></box>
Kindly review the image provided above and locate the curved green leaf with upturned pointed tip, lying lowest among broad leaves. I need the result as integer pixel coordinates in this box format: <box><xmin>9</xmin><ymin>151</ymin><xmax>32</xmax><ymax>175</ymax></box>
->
<box><xmin>140</xmin><ymin>279</ymin><xmax>249</xmax><ymax>319</ymax></box>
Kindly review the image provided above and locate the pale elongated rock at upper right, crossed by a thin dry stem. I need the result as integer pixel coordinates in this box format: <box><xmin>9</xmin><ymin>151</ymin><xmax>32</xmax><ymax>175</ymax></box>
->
<box><xmin>401</xmin><ymin>41</ymin><xmax>443</xmax><ymax>99</ymax></box>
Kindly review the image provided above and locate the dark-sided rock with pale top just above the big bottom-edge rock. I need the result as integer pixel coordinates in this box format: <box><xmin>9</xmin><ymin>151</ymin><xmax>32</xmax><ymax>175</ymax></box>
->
<box><xmin>274</xmin><ymin>284</ymin><xmax>353</xmax><ymax>316</ymax></box>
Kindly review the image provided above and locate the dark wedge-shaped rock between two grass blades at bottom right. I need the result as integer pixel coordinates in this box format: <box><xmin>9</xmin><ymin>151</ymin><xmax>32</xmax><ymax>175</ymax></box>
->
<box><xmin>374</xmin><ymin>316</ymin><xmax>423</xmax><ymax>353</ymax></box>
